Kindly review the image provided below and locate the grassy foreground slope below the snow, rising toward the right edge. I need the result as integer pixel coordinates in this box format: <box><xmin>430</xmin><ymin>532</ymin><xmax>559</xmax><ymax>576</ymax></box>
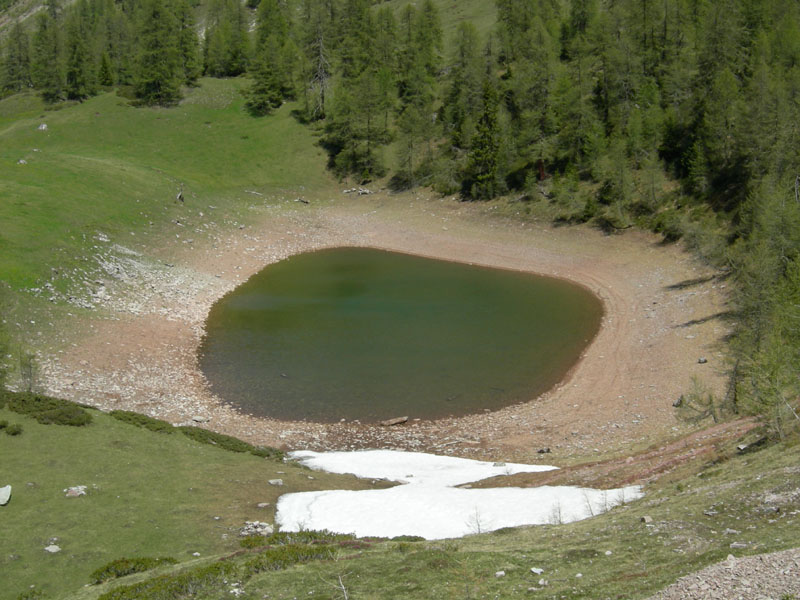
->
<box><xmin>67</xmin><ymin>436</ymin><xmax>800</xmax><ymax>600</ymax></box>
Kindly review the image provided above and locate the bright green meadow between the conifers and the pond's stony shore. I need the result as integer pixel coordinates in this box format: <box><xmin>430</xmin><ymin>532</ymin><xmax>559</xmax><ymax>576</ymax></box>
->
<box><xmin>0</xmin><ymin>79</ymin><xmax>330</xmax><ymax>287</ymax></box>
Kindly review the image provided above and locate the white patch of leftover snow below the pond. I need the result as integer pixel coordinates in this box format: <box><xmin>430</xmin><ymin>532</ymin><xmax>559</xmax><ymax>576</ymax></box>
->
<box><xmin>275</xmin><ymin>450</ymin><xmax>643</xmax><ymax>540</ymax></box>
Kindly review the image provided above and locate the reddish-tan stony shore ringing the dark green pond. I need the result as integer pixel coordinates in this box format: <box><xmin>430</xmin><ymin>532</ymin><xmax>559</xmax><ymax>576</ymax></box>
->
<box><xmin>41</xmin><ymin>194</ymin><xmax>726</xmax><ymax>464</ymax></box>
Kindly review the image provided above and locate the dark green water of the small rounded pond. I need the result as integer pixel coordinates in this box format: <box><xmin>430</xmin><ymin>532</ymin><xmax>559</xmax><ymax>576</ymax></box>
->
<box><xmin>200</xmin><ymin>248</ymin><xmax>602</xmax><ymax>422</ymax></box>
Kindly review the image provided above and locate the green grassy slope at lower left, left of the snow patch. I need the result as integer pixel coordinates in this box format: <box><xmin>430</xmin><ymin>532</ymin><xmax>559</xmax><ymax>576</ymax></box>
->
<box><xmin>0</xmin><ymin>409</ymin><xmax>386</xmax><ymax>599</ymax></box>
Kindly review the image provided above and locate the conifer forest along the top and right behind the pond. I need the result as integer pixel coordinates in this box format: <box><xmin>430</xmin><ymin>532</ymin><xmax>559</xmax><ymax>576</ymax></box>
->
<box><xmin>0</xmin><ymin>0</ymin><xmax>800</xmax><ymax>431</ymax></box>
